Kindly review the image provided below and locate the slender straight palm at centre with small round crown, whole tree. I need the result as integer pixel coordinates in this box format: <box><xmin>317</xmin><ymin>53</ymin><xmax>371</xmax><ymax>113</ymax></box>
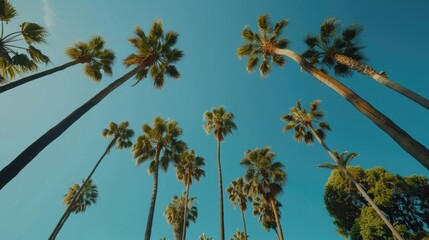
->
<box><xmin>203</xmin><ymin>105</ymin><xmax>237</xmax><ymax>240</ymax></box>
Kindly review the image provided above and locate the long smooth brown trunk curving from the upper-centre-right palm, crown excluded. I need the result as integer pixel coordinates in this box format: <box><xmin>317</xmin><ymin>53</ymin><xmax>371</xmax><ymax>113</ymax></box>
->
<box><xmin>275</xmin><ymin>49</ymin><xmax>429</xmax><ymax>170</ymax></box>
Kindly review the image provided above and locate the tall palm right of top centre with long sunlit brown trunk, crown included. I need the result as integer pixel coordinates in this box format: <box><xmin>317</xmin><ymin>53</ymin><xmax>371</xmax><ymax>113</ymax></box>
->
<box><xmin>237</xmin><ymin>14</ymin><xmax>429</xmax><ymax>170</ymax></box>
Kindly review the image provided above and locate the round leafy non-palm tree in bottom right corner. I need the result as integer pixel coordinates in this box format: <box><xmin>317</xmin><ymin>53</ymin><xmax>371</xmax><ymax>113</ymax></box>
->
<box><xmin>324</xmin><ymin>167</ymin><xmax>429</xmax><ymax>240</ymax></box>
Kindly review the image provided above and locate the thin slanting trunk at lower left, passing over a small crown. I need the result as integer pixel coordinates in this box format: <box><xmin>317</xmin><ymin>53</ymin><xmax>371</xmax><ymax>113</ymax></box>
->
<box><xmin>49</xmin><ymin>137</ymin><xmax>118</xmax><ymax>240</ymax></box>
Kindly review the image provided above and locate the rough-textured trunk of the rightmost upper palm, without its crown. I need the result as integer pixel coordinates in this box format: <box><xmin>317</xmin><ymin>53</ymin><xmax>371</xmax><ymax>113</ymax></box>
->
<box><xmin>333</xmin><ymin>54</ymin><xmax>429</xmax><ymax>109</ymax></box>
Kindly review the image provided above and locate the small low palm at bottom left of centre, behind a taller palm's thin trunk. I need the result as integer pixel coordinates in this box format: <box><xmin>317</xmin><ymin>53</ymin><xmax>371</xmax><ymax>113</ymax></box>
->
<box><xmin>164</xmin><ymin>193</ymin><xmax>198</xmax><ymax>240</ymax></box>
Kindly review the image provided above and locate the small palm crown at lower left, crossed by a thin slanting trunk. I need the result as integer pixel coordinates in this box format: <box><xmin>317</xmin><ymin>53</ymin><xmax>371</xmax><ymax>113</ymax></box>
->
<box><xmin>63</xmin><ymin>179</ymin><xmax>98</xmax><ymax>213</ymax></box>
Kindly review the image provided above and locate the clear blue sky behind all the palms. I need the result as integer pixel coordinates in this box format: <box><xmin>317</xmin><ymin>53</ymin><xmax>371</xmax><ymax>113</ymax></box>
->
<box><xmin>0</xmin><ymin>0</ymin><xmax>429</xmax><ymax>240</ymax></box>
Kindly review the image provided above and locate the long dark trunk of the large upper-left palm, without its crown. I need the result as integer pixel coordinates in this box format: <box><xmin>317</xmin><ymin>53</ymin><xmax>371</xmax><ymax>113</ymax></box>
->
<box><xmin>0</xmin><ymin>64</ymin><xmax>147</xmax><ymax>189</ymax></box>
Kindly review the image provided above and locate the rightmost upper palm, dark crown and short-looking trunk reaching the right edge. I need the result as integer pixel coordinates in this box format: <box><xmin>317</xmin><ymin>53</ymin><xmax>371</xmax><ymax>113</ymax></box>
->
<box><xmin>302</xmin><ymin>17</ymin><xmax>429</xmax><ymax>109</ymax></box>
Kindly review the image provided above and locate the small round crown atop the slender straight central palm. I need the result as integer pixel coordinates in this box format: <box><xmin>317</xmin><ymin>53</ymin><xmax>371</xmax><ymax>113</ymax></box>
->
<box><xmin>203</xmin><ymin>105</ymin><xmax>237</xmax><ymax>142</ymax></box>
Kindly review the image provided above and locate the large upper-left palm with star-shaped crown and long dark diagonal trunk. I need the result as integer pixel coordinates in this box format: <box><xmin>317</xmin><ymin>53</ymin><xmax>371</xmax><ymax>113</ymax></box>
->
<box><xmin>0</xmin><ymin>20</ymin><xmax>183</xmax><ymax>189</ymax></box>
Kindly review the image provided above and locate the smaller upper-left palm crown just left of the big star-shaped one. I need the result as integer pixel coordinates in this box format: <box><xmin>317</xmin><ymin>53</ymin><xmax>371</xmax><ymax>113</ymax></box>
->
<box><xmin>65</xmin><ymin>36</ymin><xmax>115</xmax><ymax>82</ymax></box>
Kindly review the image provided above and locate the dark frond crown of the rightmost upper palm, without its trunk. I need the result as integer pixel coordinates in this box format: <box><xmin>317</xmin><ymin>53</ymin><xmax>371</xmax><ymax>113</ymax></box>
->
<box><xmin>302</xmin><ymin>17</ymin><xmax>366</xmax><ymax>77</ymax></box>
